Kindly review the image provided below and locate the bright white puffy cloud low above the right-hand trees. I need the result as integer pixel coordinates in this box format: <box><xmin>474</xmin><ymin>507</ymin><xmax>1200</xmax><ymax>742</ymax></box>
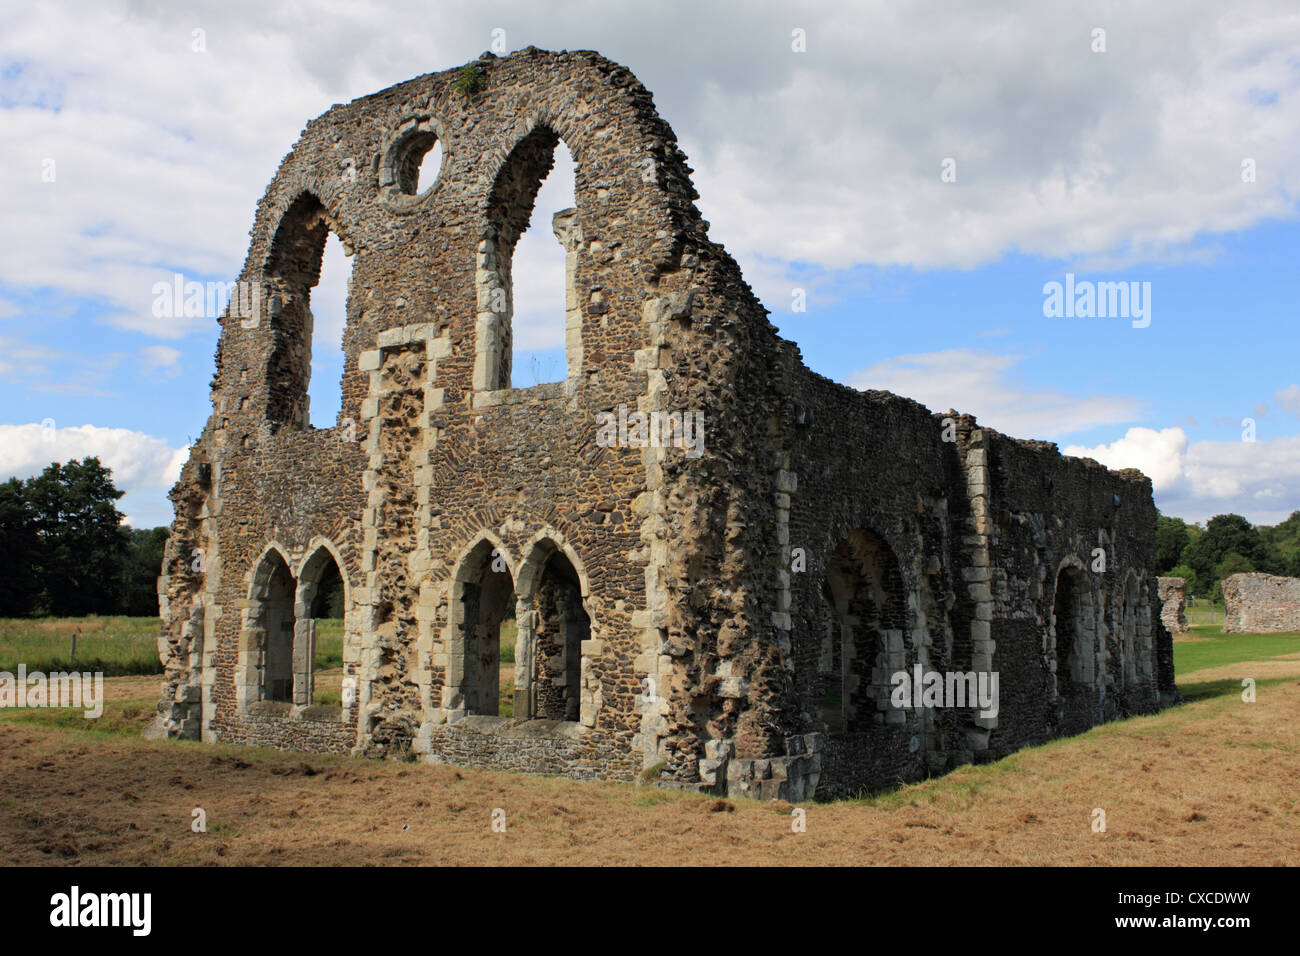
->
<box><xmin>1063</xmin><ymin>428</ymin><xmax>1300</xmax><ymax>524</ymax></box>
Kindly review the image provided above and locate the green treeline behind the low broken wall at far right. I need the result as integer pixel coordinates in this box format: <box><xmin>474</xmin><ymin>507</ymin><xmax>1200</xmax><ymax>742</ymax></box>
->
<box><xmin>1156</xmin><ymin>511</ymin><xmax>1300</xmax><ymax>601</ymax></box>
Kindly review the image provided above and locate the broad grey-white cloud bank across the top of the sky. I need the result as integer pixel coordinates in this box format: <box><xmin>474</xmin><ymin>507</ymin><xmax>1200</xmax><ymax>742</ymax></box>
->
<box><xmin>0</xmin><ymin>0</ymin><xmax>1300</xmax><ymax>332</ymax></box>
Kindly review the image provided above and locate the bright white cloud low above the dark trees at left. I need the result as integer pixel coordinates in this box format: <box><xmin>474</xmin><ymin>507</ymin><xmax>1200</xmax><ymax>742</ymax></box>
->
<box><xmin>0</xmin><ymin>423</ymin><xmax>190</xmax><ymax>494</ymax></box>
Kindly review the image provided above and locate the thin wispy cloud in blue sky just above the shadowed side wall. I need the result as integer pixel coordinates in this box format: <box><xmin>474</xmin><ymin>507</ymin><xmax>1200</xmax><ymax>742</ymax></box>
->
<box><xmin>848</xmin><ymin>349</ymin><xmax>1141</xmax><ymax>438</ymax></box>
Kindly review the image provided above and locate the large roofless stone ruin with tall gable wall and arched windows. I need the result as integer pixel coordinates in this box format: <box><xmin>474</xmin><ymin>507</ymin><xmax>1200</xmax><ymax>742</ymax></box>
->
<box><xmin>151</xmin><ymin>48</ymin><xmax>1178</xmax><ymax>800</ymax></box>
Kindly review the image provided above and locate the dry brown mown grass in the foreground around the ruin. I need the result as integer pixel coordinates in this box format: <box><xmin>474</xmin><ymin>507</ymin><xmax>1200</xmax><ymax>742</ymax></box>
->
<box><xmin>0</xmin><ymin>635</ymin><xmax>1300</xmax><ymax>866</ymax></box>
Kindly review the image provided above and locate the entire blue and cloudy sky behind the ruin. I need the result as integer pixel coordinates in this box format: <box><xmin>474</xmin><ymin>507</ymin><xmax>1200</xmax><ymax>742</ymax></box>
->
<box><xmin>0</xmin><ymin>0</ymin><xmax>1300</xmax><ymax>525</ymax></box>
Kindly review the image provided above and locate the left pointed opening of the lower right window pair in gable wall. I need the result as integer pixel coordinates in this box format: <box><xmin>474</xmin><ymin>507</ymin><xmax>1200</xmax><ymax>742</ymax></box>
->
<box><xmin>442</xmin><ymin>532</ymin><xmax>517</xmax><ymax>717</ymax></box>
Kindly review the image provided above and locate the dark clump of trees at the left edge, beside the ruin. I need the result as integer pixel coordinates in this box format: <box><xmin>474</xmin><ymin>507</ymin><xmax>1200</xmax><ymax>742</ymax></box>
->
<box><xmin>0</xmin><ymin>458</ymin><xmax>169</xmax><ymax>618</ymax></box>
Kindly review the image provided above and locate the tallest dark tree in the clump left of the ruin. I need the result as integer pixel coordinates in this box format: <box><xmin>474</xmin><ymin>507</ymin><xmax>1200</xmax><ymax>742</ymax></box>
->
<box><xmin>25</xmin><ymin>458</ymin><xmax>129</xmax><ymax>617</ymax></box>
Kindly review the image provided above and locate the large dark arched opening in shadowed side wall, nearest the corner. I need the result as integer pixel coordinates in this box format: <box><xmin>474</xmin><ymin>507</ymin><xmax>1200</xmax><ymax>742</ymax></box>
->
<box><xmin>820</xmin><ymin>528</ymin><xmax>909</xmax><ymax>734</ymax></box>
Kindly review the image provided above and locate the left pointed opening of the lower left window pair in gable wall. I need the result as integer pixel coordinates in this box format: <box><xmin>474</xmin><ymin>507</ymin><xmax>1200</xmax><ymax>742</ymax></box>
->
<box><xmin>235</xmin><ymin>544</ymin><xmax>299</xmax><ymax>708</ymax></box>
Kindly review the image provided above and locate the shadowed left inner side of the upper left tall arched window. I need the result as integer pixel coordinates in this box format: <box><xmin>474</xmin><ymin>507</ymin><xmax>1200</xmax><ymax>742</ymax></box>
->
<box><xmin>263</xmin><ymin>190</ymin><xmax>351</xmax><ymax>431</ymax></box>
